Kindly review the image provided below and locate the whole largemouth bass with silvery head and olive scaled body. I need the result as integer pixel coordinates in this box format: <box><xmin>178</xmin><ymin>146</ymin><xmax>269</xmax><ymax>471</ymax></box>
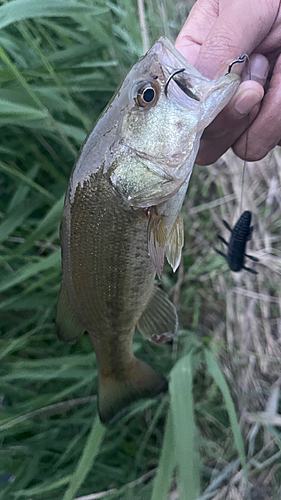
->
<box><xmin>56</xmin><ymin>37</ymin><xmax>240</xmax><ymax>424</ymax></box>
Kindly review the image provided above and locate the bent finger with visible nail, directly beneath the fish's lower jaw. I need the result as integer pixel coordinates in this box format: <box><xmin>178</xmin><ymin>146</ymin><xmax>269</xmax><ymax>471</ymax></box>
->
<box><xmin>196</xmin><ymin>80</ymin><xmax>264</xmax><ymax>165</ymax></box>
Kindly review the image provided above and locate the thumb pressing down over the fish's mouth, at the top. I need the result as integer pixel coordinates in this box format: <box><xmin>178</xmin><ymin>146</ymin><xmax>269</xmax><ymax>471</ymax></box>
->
<box><xmin>192</xmin><ymin>0</ymin><xmax>280</xmax><ymax>79</ymax></box>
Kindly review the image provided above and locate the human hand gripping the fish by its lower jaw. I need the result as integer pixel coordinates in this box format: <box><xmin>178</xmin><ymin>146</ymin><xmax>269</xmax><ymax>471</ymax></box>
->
<box><xmin>175</xmin><ymin>0</ymin><xmax>281</xmax><ymax>165</ymax></box>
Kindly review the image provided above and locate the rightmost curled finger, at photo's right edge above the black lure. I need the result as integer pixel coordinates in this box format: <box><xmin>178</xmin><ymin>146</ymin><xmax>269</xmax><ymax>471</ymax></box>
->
<box><xmin>233</xmin><ymin>52</ymin><xmax>281</xmax><ymax>161</ymax></box>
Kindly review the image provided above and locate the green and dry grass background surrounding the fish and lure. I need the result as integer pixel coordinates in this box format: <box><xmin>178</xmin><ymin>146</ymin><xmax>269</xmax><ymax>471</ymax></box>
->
<box><xmin>0</xmin><ymin>0</ymin><xmax>281</xmax><ymax>500</ymax></box>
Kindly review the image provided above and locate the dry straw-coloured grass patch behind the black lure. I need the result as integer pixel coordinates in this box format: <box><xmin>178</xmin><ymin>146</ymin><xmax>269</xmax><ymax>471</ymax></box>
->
<box><xmin>171</xmin><ymin>148</ymin><xmax>281</xmax><ymax>500</ymax></box>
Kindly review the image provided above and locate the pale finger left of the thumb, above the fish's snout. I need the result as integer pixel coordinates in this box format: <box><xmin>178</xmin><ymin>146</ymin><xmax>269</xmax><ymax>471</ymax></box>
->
<box><xmin>175</xmin><ymin>0</ymin><xmax>219</xmax><ymax>64</ymax></box>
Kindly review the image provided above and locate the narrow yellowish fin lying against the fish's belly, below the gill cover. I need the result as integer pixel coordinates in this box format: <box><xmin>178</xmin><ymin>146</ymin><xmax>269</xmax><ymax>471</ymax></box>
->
<box><xmin>148</xmin><ymin>207</ymin><xmax>167</xmax><ymax>278</ymax></box>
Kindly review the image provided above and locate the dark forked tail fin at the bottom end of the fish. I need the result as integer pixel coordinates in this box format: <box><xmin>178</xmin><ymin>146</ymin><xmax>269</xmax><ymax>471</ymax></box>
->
<box><xmin>98</xmin><ymin>358</ymin><xmax>168</xmax><ymax>424</ymax></box>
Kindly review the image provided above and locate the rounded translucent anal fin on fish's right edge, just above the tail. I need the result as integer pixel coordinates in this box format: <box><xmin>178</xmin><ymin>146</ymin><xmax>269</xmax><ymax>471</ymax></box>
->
<box><xmin>137</xmin><ymin>285</ymin><xmax>178</xmax><ymax>344</ymax></box>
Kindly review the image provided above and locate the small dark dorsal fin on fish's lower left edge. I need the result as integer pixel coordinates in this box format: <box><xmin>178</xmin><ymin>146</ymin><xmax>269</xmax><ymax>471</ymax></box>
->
<box><xmin>56</xmin><ymin>282</ymin><xmax>85</xmax><ymax>344</ymax></box>
